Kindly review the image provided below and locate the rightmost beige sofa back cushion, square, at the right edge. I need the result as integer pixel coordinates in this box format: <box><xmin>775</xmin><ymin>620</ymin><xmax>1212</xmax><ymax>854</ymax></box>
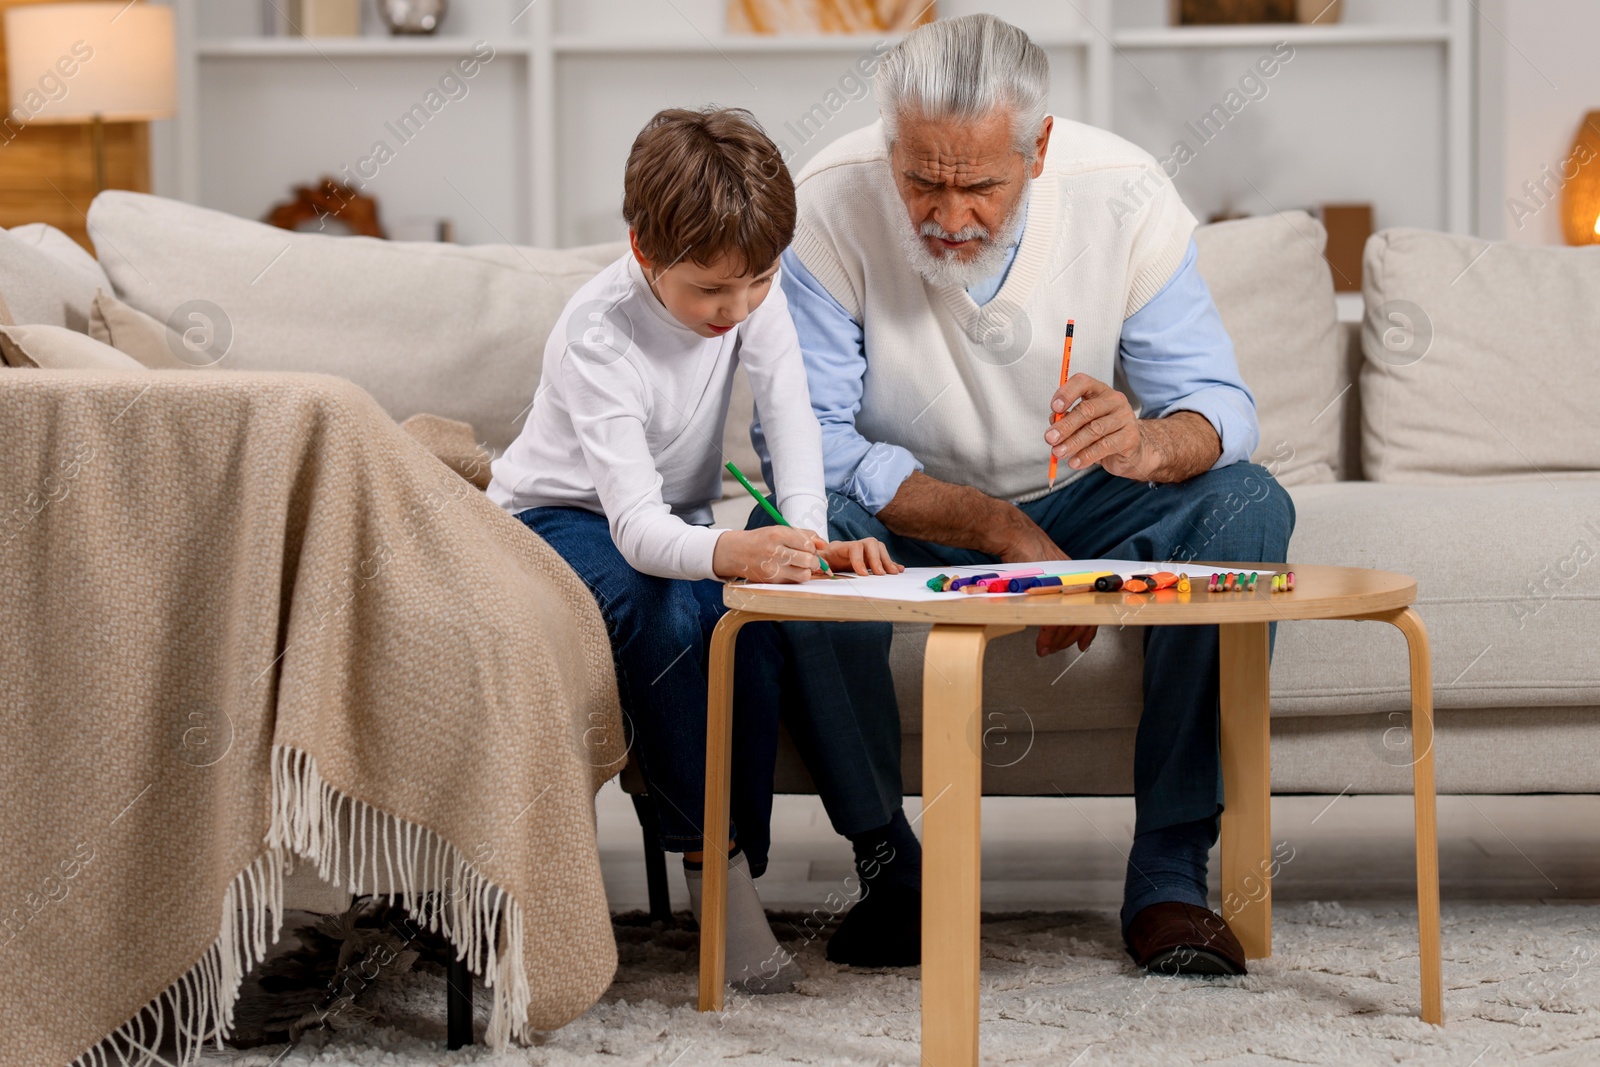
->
<box><xmin>1362</xmin><ymin>229</ymin><xmax>1600</xmax><ymax>483</ymax></box>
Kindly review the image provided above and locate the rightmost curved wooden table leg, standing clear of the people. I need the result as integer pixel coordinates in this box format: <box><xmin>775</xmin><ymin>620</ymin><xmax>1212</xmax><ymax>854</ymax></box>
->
<box><xmin>1389</xmin><ymin>608</ymin><xmax>1445</xmax><ymax>1025</ymax></box>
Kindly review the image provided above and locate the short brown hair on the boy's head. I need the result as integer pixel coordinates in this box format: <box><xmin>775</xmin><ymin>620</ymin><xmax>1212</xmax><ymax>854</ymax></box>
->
<box><xmin>622</xmin><ymin>107</ymin><xmax>795</xmax><ymax>275</ymax></box>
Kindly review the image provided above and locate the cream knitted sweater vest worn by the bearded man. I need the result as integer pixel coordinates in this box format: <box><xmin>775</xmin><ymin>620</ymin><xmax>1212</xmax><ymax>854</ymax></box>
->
<box><xmin>794</xmin><ymin>118</ymin><xmax>1195</xmax><ymax>501</ymax></box>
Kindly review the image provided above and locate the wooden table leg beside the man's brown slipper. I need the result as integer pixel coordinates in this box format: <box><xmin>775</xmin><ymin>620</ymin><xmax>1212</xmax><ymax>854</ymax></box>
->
<box><xmin>1218</xmin><ymin>622</ymin><xmax>1272</xmax><ymax>960</ymax></box>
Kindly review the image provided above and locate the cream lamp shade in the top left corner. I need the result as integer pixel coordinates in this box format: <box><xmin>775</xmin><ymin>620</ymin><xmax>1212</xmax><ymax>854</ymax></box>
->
<box><xmin>5</xmin><ymin>0</ymin><xmax>178</xmax><ymax>123</ymax></box>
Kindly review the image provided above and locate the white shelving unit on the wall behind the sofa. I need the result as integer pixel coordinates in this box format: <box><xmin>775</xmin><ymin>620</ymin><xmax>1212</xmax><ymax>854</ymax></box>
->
<box><xmin>171</xmin><ymin>0</ymin><xmax>1475</xmax><ymax>245</ymax></box>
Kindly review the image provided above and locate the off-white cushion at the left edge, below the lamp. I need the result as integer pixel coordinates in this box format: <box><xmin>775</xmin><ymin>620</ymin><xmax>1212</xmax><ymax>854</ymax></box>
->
<box><xmin>0</xmin><ymin>222</ymin><xmax>110</xmax><ymax>333</ymax></box>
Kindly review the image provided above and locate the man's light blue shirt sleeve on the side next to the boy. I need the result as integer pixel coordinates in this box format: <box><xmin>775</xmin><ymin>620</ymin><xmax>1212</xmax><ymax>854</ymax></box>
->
<box><xmin>750</xmin><ymin>250</ymin><xmax>922</xmax><ymax>515</ymax></box>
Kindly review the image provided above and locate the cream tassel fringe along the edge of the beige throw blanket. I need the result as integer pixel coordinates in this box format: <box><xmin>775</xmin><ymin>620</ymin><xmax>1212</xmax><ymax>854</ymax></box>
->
<box><xmin>72</xmin><ymin>745</ymin><xmax>531</xmax><ymax>1067</ymax></box>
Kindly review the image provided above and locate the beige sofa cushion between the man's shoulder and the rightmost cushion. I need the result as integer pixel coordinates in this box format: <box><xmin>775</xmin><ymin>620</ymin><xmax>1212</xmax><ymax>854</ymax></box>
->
<box><xmin>1195</xmin><ymin>211</ymin><xmax>1344</xmax><ymax>485</ymax></box>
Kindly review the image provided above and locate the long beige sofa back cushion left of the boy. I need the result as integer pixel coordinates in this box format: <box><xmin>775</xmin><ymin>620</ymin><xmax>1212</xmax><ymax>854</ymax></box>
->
<box><xmin>85</xmin><ymin>192</ymin><xmax>624</xmax><ymax>450</ymax></box>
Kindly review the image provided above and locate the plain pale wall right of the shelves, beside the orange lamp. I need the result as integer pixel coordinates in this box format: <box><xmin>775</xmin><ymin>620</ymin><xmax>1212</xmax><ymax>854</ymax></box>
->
<box><xmin>1478</xmin><ymin>0</ymin><xmax>1600</xmax><ymax>245</ymax></box>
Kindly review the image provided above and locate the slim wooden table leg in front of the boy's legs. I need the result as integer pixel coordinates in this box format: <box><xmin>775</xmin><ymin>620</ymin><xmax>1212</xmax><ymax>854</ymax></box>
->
<box><xmin>699</xmin><ymin>611</ymin><xmax>762</xmax><ymax>1011</ymax></box>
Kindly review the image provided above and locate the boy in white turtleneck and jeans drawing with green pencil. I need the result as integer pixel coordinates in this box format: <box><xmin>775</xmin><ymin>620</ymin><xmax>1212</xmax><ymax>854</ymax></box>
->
<box><xmin>490</xmin><ymin>109</ymin><xmax>904</xmax><ymax>992</ymax></box>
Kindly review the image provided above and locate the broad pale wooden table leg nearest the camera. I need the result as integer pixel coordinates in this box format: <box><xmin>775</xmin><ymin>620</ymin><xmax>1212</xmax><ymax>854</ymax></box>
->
<box><xmin>922</xmin><ymin>625</ymin><xmax>1021</xmax><ymax>1067</ymax></box>
